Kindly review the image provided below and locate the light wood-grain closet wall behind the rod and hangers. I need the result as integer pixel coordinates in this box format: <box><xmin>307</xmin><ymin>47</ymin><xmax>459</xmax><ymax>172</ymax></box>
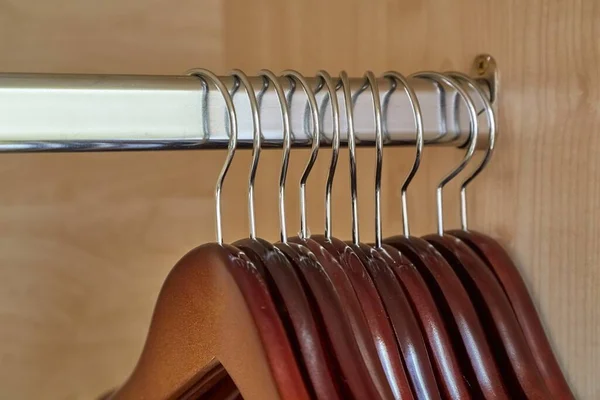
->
<box><xmin>0</xmin><ymin>0</ymin><xmax>600</xmax><ymax>399</ymax></box>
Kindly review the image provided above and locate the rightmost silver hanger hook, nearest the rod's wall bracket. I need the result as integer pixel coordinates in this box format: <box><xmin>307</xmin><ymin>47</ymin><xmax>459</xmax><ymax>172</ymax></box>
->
<box><xmin>446</xmin><ymin>71</ymin><xmax>498</xmax><ymax>231</ymax></box>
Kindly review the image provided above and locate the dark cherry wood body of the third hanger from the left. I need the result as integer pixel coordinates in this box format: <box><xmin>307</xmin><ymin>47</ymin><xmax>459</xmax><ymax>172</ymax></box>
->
<box><xmin>275</xmin><ymin>242</ymin><xmax>386</xmax><ymax>399</ymax></box>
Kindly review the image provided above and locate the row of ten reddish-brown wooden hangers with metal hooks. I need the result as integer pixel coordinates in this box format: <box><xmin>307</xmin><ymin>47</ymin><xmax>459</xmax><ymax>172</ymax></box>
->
<box><xmin>102</xmin><ymin>57</ymin><xmax>574</xmax><ymax>400</ymax></box>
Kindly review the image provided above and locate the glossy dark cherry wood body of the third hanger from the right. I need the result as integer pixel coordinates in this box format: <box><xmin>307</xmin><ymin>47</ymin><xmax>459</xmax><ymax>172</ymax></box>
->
<box><xmin>384</xmin><ymin>235</ymin><xmax>512</xmax><ymax>399</ymax></box>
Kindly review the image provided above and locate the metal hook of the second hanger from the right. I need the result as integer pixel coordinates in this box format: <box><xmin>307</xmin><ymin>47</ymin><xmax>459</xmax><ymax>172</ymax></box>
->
<box><xmin>413</xmin><ymin>72</ymin><xmax>479</xmax><ymax>236</ymax></box>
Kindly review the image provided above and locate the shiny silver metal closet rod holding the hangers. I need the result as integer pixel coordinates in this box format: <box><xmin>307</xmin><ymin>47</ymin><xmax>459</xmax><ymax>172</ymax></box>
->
<box><xmin>0</xmin><ymin>65</ymin><xmax>490</xmax><ymax>152</ymax></box>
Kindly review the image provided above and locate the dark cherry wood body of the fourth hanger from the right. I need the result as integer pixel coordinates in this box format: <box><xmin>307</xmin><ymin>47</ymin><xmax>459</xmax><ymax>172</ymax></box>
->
<box><xmin>370</xmin><ymin>244</ymin><xmax>480</xmax><ymax>399</ymax></box>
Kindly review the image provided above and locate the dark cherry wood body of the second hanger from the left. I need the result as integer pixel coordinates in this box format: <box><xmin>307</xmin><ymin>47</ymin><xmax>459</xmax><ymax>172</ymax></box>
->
<box><xmin>234</xmin><ymin>239</ymin><xmax>348</xmax><ymax>400</ymax></box>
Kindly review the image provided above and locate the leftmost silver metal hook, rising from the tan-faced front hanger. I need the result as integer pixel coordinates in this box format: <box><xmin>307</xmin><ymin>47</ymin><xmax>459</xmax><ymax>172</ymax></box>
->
<box><xmin>188</xmin><ymin>68</ymin><xmax>238</xmax><ymax>244</ymax></box>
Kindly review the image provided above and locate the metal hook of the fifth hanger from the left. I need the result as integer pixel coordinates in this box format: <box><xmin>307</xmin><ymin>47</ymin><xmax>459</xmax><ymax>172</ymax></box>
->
<box><xmin>316</xmin><ymin>70</ymin><xmax>340</xmax><ymax>242</ymax></box>
